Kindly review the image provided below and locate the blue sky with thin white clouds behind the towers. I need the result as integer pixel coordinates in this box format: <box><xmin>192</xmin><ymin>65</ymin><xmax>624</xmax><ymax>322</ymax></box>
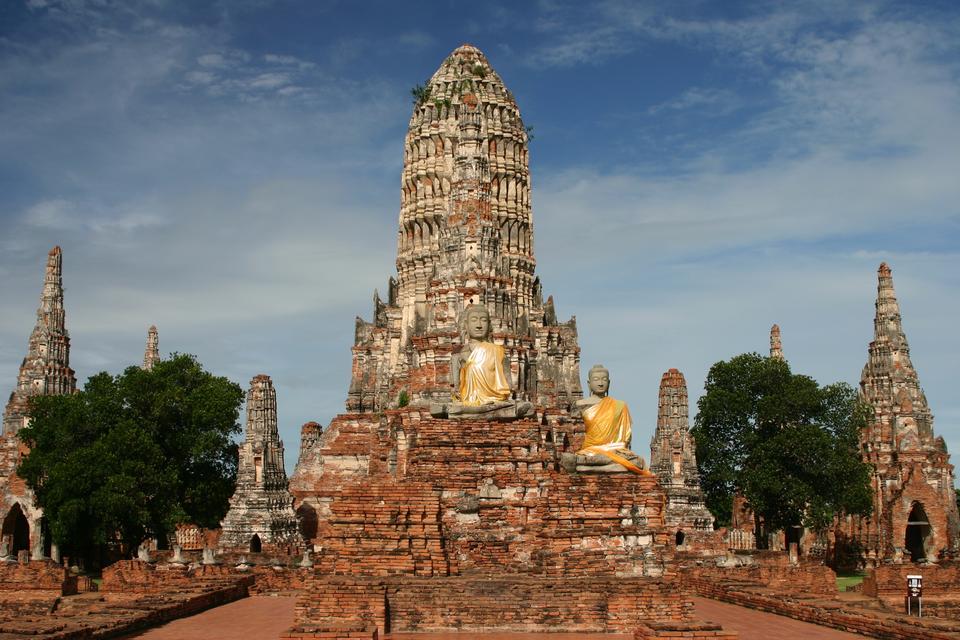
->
<box><xmin>0</xmin><ymin>0</ymin><xmax>960</xmax><ymax>476</ymax></box>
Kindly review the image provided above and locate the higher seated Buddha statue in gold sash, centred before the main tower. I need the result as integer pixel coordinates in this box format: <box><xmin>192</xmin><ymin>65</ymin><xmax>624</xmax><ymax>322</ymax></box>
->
<box><xmin>430</xmin><ymin>304</ymin><xmax>532</xmax><ymax>418</ymax></box>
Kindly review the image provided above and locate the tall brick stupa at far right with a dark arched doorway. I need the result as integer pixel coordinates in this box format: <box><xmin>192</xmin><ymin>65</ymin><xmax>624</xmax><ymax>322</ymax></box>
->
<box><xmin>842</xmin><ymin>263</ymin><xmax>960</xmax><ymax>564</ymax></box>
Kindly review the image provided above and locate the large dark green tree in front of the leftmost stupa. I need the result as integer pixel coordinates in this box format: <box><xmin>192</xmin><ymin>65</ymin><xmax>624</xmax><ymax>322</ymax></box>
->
<box><xmin>18</xmin><ymin>355</ymin><xmax>243</xmax><ymax>560</ymax></box>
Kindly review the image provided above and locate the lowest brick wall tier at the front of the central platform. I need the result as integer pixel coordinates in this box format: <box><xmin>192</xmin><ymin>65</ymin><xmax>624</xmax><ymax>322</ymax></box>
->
<box><xmin>292</xmin><ymin>574</ymin><xmax>695</xmax><ymax>633</ymax></box>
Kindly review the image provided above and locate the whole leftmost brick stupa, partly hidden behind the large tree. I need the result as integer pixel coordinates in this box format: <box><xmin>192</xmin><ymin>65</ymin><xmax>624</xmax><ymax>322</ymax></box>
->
<box><xmin>0</xmin><ymin>247</ymin><xmax>77</xmax><ymax>557</ymax></box>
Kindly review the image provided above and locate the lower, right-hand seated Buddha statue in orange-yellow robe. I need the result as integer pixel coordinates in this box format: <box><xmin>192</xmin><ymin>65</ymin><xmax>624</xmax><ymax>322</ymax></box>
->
<box><xmin>561</xmin><ymin>364</ymin><xmax>651</xmax><ymax>476</ymax></box>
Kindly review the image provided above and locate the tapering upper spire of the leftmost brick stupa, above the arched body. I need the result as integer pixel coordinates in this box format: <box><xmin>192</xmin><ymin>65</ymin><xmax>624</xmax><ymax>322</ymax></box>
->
<box><xmin>3</xmin><ymin>247</ymin><xmax>77</xmax><ymax>435</ymax></box>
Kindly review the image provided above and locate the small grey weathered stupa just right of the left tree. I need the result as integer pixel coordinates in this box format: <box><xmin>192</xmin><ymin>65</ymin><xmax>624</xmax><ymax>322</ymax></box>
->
<box><xmin>220</xmin><ymin>375</ymin><xmax>303</xmax><ymax>553</ymax></box>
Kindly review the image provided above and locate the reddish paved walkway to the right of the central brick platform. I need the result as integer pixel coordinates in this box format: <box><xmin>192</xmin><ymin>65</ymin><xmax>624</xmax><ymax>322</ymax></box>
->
<box><xmin>693</xmin><ymin>597</ymin><xmax>864</xmax><ymax>640</ymax></box>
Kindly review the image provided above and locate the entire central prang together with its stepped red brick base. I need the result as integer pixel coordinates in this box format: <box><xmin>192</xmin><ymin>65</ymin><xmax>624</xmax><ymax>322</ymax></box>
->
<box><xmin>285</xmin><ymin>45</ymin><xmax>724</xmax><ymax>638</ymax></box>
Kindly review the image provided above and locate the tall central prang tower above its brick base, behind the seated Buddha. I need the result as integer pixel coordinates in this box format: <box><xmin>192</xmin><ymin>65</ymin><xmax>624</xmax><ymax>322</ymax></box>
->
<box><xmin>347</xmin><ymin>45</ymin><xmax>583</xmax><ymax>412</ymax></box>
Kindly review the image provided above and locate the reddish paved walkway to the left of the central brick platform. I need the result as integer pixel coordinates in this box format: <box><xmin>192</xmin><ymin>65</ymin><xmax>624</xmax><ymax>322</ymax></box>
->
<box><xmin>131</xmin><ymin>596</ymin><xmax>297</xmax><ymax>640</ymax></box>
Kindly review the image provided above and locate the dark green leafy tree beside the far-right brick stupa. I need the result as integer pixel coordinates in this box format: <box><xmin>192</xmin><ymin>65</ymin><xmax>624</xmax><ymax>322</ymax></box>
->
<box><xmin>692</xmin><ymin>353</ymin><xmax>872</xmax><ymax>544</ymax></box>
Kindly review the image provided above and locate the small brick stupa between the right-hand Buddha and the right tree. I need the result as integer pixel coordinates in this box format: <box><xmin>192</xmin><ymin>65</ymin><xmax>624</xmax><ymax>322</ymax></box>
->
<box><xmin>650</xmin><ymin>369</ymin><xmax>713</xmax><ymax>546</ymax></box>
